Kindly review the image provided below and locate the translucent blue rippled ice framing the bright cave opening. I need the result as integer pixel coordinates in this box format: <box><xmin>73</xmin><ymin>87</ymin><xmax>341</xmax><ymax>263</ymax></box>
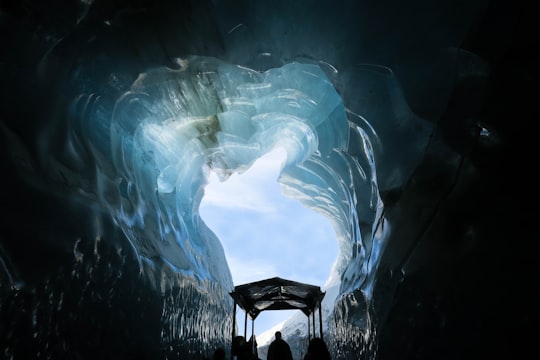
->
<box><xmin>10</xmin><ymin>52</ymin><xmax>431</xmax><ymax>358</ymax></box>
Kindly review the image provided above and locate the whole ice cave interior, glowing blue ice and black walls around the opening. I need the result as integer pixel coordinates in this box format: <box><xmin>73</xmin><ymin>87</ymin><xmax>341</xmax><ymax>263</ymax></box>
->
<box><xmin>0</xmin><ymin>0</ymin><xmax>539</xmax><ymax>360</ymax></box>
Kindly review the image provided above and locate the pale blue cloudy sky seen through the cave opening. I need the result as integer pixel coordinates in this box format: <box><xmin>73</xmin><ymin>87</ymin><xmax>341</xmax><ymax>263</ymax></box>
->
<box><xmin>199</xmin><ymin>149</ymin><xmax>338</xmax><ymax>337</ymax></box>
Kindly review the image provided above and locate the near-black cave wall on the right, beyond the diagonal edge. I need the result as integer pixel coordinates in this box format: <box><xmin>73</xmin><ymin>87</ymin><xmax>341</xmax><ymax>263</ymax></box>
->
<box><xmin>377</xmin><ymin>1</ymin><xmax>539</xmax><ymax>359</ymax></box>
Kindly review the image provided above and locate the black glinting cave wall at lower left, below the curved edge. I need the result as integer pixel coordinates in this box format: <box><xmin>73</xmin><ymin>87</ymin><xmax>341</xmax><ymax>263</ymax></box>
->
<box><xmin>0</xmin><ymin>167</ymin><xmax>163</xmax><ymax>359</ymax></box>
